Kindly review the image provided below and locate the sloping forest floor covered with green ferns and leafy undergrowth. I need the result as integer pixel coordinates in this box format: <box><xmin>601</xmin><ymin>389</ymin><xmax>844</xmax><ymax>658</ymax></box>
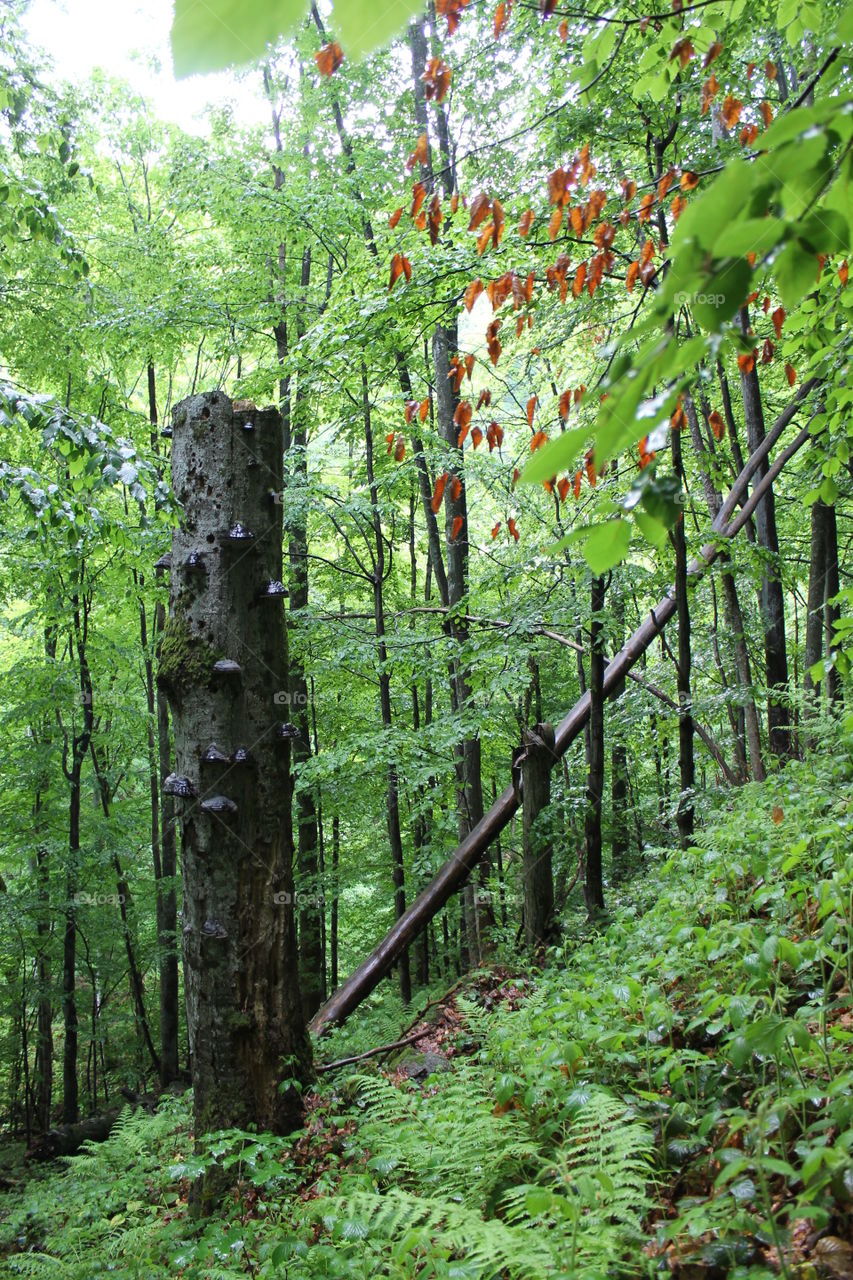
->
<box><xmin>0</xmin><ymin>742</ymin><xmax>853</xmax><ymax>1280</ymax></box>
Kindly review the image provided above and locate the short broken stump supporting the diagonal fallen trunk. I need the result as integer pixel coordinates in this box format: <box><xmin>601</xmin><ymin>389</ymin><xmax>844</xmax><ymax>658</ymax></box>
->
<box><xmin>521</xmin><ymin>724</ymin><xmax>555</xmax><ymax>951</ymax></box>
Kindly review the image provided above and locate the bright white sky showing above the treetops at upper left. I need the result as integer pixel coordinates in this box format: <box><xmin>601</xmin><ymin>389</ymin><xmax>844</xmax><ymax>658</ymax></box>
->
<box><xmin>24</xmin><ymin>0</ymin><xmax>269</xmax><ymax>133</ymax></box>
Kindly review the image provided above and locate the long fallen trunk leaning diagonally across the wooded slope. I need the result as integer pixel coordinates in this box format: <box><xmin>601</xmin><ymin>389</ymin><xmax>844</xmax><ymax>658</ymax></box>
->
<box><xmin>310</xmin><ymin>378</ymin><xmax>817</xmax><ymax>1036</ymax></box>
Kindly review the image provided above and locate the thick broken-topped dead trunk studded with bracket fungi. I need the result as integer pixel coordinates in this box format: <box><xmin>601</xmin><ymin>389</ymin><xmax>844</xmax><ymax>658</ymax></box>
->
<box><xmin>158</xmin><ymin>392</ymin><xmax>311</xmax><ymax>1207</ymax></box>
